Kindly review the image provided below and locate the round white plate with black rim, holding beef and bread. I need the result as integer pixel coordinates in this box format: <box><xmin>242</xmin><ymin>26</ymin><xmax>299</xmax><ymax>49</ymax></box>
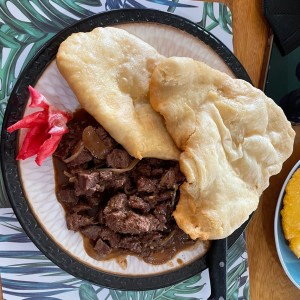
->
<box><xmin>1</xmin><ymin>9</ymin><xmax>250</xmax><ymax>290</ymax></box>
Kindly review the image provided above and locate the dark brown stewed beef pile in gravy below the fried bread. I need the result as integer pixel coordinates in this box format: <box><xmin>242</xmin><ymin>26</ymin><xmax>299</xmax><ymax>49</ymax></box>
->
<box><xmin>54</xmin><ymin>112</ymin><xmax>194</xmax><ymax>263</ymax></box>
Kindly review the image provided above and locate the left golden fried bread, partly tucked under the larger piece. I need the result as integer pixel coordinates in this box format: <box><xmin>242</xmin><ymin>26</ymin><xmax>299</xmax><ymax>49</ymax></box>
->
<box><xmin>56</xmin><ymin>27</ymin><xmax>179</xmax><ymax>160</ymax></box>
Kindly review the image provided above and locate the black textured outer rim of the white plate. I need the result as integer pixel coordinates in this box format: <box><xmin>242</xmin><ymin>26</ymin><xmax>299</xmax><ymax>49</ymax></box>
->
<box><xmin>0</xmin><ymin>9</ymin><xmax>251</xmax><ymax>291</ymax></box>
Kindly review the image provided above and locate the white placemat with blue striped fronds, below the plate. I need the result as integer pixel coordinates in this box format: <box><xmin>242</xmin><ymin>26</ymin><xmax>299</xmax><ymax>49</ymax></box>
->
<box><xmin>0</xmin><ymin>208</ymin><xmax>250</xmax><ymax>300</ymax></box>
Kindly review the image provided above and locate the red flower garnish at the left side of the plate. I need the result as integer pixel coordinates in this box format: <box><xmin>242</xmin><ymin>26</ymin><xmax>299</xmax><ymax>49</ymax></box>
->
<box><xmin>7</xmin><ymin>86</ymin><xmax>72</xmax><ymax>166</ymax></box>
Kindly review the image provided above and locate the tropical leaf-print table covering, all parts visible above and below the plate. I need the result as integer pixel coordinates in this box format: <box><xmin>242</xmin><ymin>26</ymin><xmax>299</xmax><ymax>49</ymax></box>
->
<box><xmin>0</xmin><ymin>0</ymin><xmax>249</xmax><ymax>300</ymax></box>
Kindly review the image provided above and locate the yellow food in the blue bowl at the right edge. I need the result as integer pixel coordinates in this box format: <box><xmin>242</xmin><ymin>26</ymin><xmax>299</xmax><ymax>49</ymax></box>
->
<box><xmin>281</xmin><ymin>169</ymin><xmax>300</xmax><ymax>258</ymax></box>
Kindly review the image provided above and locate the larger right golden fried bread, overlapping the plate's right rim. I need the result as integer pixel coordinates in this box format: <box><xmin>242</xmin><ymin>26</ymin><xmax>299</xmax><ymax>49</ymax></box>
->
<box><xmin>150</xmin><ymin>57</ymin><xmax>295</xmax><ymax>239</ymax></box>
